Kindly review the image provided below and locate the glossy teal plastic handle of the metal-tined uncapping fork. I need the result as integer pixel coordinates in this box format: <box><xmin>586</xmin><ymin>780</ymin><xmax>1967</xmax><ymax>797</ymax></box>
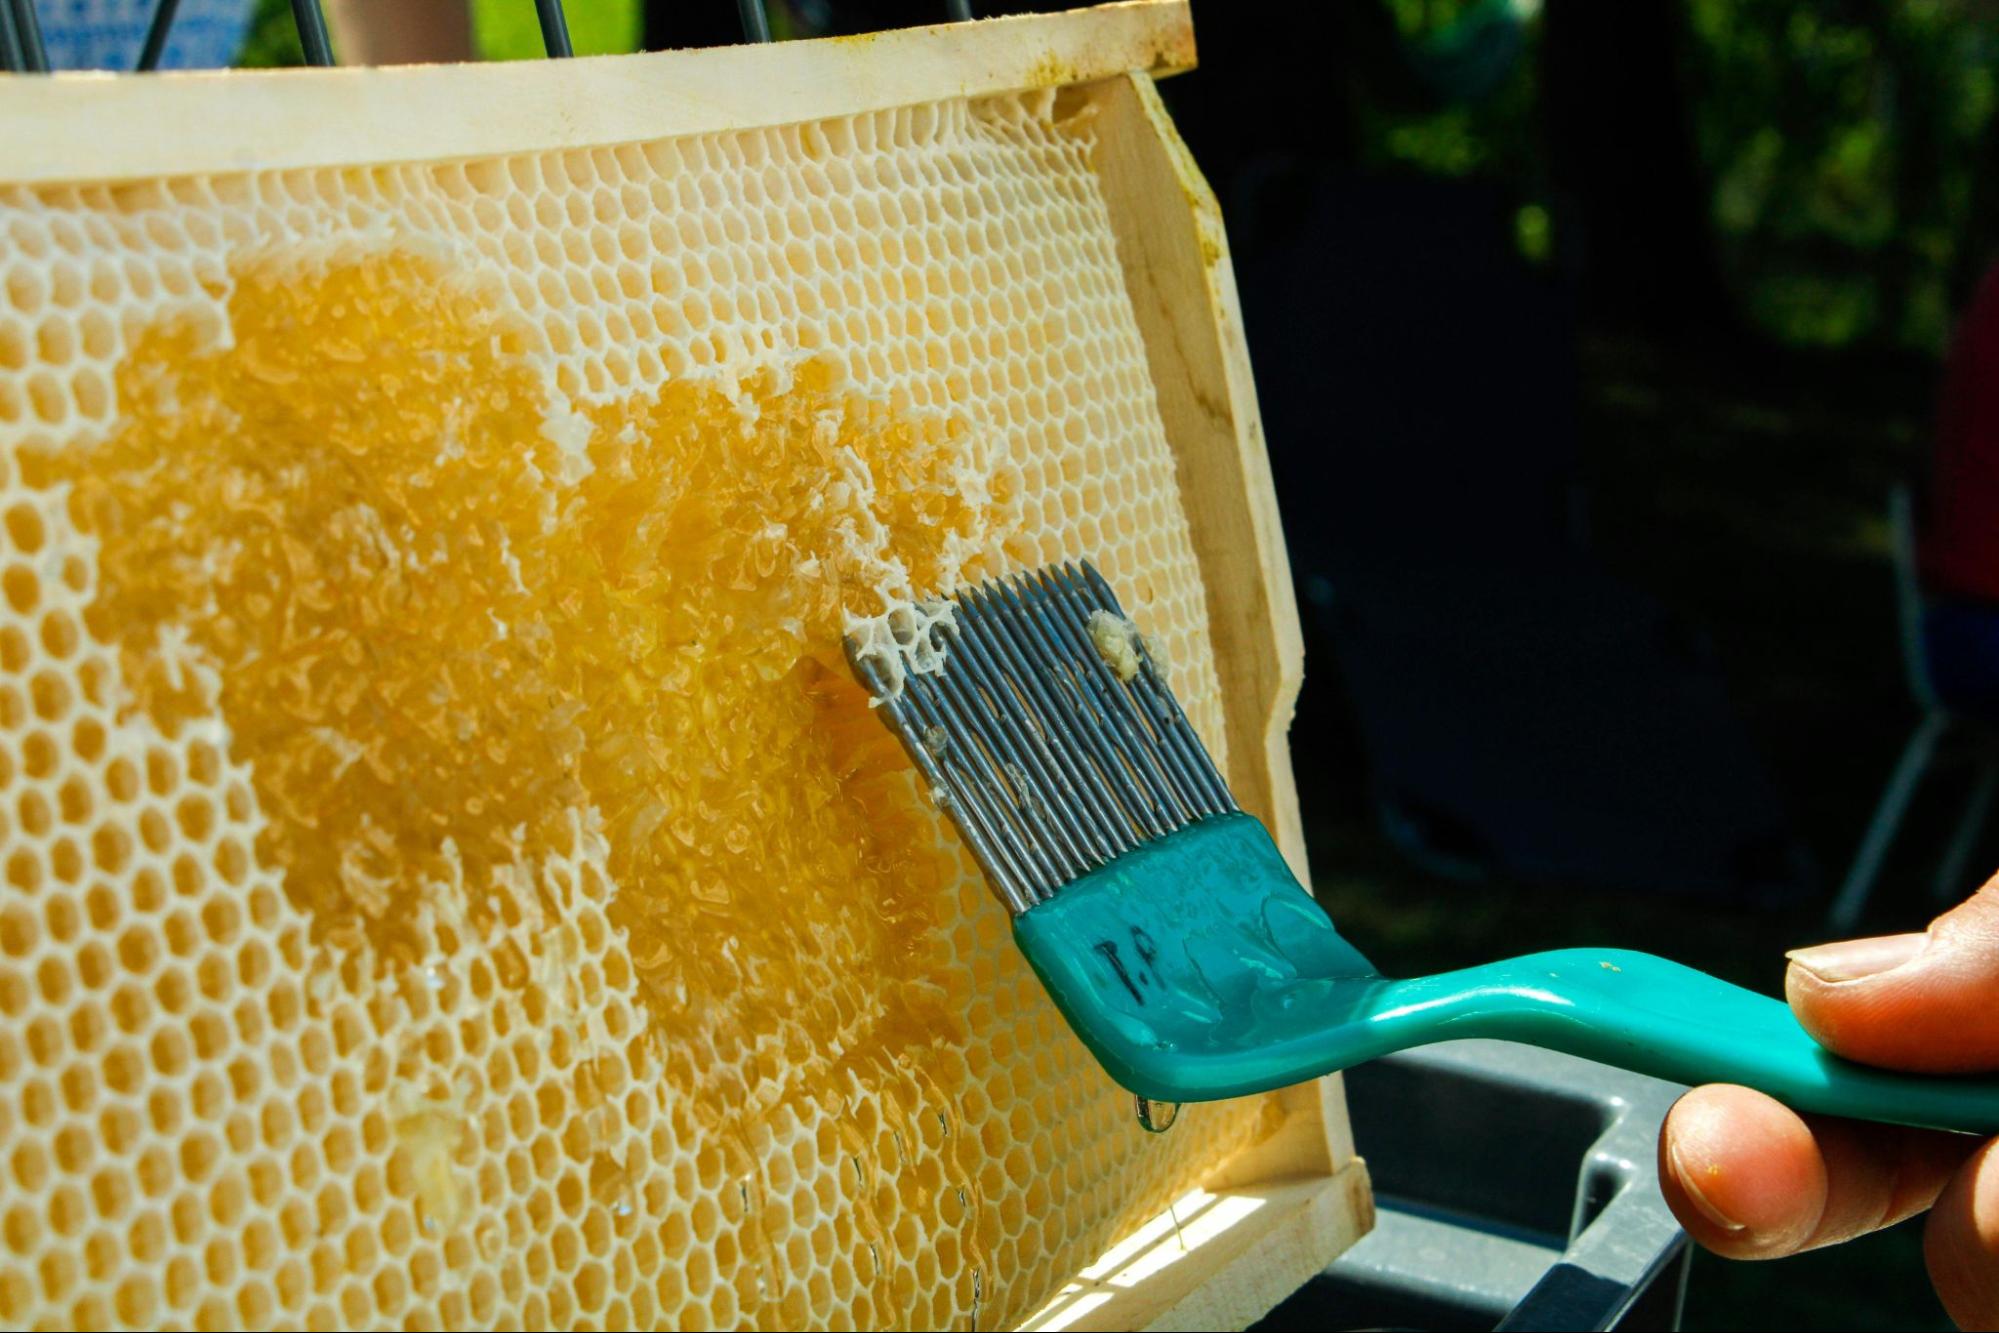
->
<box><xmin>1013</xmin><ymin>815</ymin><xmax>1999</xmax><ymax>1135</ymax></box>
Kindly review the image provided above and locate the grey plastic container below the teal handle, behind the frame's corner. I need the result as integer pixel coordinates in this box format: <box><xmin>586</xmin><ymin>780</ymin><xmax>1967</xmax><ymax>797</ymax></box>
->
<box><xmin>1255</xmin><ymin>1041</ymin><xmax>1689</xmax><ymax>1331</ymax></box>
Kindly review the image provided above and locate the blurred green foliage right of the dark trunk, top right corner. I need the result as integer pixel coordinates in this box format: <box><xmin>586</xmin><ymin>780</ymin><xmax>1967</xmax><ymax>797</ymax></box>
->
<box><xmin>1689</xmin><ymin>0</ymin><xmax>1999</xmax><ymax>348</ymax></box>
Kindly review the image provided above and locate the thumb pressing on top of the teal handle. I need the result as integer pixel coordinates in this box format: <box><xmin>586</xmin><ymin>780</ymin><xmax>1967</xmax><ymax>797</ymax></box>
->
<box><xmin>1785</xmin><ymin>875</ymin><xmax>1999</xmax><ymax>1073</ymax></box>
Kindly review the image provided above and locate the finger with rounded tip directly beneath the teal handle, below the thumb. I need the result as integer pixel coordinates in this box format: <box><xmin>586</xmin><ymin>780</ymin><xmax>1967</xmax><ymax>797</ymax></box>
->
<box><xmin>1659</xmin><ymin>1083</ymin><xmax>1977</xmax><ymax>1259</ymax></box>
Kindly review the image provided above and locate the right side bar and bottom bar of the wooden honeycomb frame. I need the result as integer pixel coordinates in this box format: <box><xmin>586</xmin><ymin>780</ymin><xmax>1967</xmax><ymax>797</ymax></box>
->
<box><xmin>1027</xmin><ymin>72</ymin><xmax>1373</xmax><ymax>1331</ymax></box>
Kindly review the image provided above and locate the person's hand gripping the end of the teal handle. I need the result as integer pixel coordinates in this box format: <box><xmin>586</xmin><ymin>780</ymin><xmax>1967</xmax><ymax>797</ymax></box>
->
<box><xmin>1659</xmin><ymin>877</ymin><xmax>1999</xmax><ymax>1329</ymax></box>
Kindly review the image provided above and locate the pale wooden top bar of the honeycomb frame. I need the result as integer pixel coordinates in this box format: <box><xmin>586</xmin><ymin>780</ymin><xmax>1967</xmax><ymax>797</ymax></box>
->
<box><xmin>0</xmin><ymin>0</ymin><xmax>1193</xmax><ymax>184</ymax></box>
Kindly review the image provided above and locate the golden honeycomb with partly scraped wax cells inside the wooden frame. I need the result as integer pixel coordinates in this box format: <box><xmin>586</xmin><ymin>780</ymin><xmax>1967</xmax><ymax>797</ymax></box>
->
<box><xmin>0</xmin><ymin>94</ymin><xmax>1275</xmax><ymax>1329</ymax></box>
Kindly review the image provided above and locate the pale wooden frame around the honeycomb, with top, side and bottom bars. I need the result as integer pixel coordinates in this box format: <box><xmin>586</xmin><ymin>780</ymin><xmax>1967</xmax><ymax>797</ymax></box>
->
<box><xmin>0</xmin><ymin>0</ymin><xmax>1371</xmax><ymax>1329</ymax></box>
